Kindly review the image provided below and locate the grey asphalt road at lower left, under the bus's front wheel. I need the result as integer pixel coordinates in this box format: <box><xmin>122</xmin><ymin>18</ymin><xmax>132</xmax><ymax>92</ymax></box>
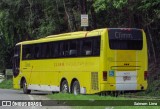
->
<box><xmin>0</xmin><ymin>89</ymin><xmax>70</xmax><ymax>109</ymax></box>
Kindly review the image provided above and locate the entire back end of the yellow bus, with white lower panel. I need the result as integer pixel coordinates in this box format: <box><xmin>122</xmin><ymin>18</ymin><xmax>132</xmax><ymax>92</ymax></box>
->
<box><xmin>101</xmin><ymin>28</ymin><xmax>148</xmax><ymax>91</ymax></box>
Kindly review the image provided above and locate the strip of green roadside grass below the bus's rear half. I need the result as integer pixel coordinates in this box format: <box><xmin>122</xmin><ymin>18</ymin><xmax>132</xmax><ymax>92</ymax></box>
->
<box><xmin>48</xmin><ymin>93</ymin><xmax>159</xmax><ymax>109</ymax></box>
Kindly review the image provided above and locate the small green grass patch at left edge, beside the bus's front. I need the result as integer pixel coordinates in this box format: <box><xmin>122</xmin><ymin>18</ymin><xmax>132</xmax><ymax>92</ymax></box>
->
<box><xmin>0</xmin><ymin>79</ymin><xmax>13</xmax><ymax>89</ymax></box>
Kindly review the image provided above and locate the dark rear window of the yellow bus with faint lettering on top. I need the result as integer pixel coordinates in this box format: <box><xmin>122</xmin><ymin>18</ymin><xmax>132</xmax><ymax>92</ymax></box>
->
<box><xmin>108</xmin><ymin>29</ymin><xmax>143</xmax><ymax>50</ymax></box>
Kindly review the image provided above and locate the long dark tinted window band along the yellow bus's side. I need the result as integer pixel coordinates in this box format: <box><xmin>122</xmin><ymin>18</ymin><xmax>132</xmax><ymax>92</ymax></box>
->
<box><xmin>22</xmin><ymin>36</ymin><xmax>100</xmax><ymax>60</ymax></box>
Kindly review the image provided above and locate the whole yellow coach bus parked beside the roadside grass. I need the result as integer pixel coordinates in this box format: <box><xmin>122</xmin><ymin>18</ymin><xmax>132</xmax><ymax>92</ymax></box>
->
<box><xmin>13</xmin><ymin>28</ymin><xmax>148</xmax><ymax>94</ymax></box>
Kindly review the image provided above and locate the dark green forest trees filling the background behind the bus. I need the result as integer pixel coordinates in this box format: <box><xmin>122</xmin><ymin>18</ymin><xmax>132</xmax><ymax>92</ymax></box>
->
<box><xmin>0</xmin><ymin>0</ymin><xmax>160</xmax><ymax>70</ymax></box>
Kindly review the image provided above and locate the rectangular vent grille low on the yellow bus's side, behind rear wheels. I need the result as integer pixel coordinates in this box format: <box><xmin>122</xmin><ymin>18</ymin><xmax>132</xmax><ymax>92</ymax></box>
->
<box><xmin>91</xmin><ymin>72</ymin><xmax>98</xmax><ymax>90</ymax></box>
